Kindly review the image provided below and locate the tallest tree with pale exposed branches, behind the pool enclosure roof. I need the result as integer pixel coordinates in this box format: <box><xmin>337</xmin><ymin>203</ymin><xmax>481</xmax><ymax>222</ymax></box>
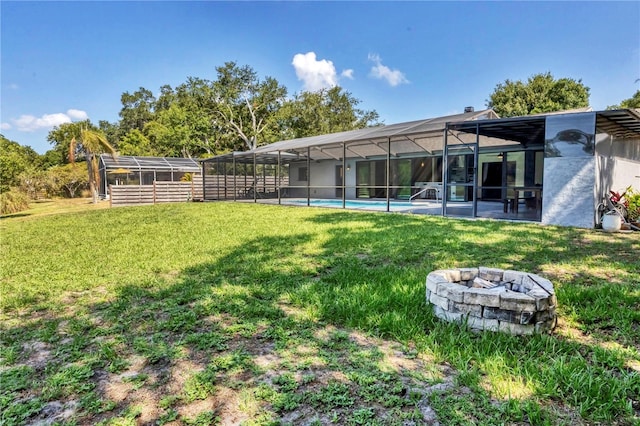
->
<box><xmin>214</xmin><ymin>62</ymin><xmax>287</xmax><ymax>149</ymax></box>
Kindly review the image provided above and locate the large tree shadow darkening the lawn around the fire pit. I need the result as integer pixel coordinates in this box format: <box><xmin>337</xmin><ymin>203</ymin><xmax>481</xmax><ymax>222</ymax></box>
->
<box><xmin>2</xmin><ymin>212</ymin><xmax>640</xmax><ymax>424</ymax></box>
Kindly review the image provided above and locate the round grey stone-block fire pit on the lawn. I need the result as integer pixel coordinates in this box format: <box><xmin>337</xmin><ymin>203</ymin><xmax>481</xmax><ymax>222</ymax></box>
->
<box><xmin>427</xmin><ymin>266</ymin><xmax>557</xmax><ymax>335</ymax></box>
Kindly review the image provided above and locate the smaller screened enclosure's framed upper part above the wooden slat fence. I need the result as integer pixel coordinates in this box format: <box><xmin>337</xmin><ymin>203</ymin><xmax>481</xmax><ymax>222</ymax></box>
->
<box><xmin>99</xmin><ymin>154</ymin><xmax>201</xmax><ymax>198</ymax></box>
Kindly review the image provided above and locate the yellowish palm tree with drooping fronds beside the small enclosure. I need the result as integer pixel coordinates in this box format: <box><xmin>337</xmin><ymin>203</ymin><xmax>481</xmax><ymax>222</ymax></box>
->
<box><xmin>69</xmin><ymin>127</ymin><xmax>116</xmax><ymax>204</ymax></box>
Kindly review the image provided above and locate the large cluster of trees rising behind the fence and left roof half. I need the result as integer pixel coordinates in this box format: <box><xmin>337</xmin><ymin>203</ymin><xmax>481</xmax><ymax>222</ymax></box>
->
<box><xmin>47</xmin><ymin>62</ymin><xmax>380</xmax><ymax>163</ymax></box>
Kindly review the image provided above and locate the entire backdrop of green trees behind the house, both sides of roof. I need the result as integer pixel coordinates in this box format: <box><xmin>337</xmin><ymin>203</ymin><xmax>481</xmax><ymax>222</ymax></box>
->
<box><xmin>0</xmin><ymin>62</ymin><xmax>640</xmax><ymax>213</ymax></box>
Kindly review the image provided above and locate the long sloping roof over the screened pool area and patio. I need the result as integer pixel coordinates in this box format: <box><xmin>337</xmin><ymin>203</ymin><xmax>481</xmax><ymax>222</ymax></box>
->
<box><xmin>203</xmin><ymin>109</ymin><xmax>640</xmax><ymax>164</ymax></box>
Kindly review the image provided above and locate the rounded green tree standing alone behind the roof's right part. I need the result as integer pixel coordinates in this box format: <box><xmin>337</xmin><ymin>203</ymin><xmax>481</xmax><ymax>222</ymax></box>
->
<box><xmin>487</xmin><ymin>72</ymin><xmax>589</xmax><ymax>117</ymax></box>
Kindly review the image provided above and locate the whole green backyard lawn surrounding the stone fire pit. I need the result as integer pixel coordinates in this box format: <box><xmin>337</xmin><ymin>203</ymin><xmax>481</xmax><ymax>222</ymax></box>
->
<box><xmin>0</xmin><ymin>203</ymin><xmax>640</xmax><ymax>425</ymax></box>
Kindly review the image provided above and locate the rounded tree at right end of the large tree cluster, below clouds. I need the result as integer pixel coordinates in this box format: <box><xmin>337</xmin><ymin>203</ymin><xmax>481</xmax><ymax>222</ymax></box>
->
<box><xmin>280</xmin><ymin>86</ymin><xmax>379</xmax><ymax>138</ymax></box>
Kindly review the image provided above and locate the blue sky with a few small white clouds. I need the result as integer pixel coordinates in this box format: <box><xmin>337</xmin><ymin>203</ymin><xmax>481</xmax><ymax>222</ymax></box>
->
<box><xmin>0</xmin><ymin>0</ymin><xmax>640</xmax><ymax>153</ymax></box>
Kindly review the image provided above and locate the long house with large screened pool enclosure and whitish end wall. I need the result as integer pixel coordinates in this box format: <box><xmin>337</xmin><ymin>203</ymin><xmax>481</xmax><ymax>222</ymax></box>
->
<box><xmin>203</xmin><ymin>108</ymin><xmax>640</xmax><ymax>227</ymax></box>
